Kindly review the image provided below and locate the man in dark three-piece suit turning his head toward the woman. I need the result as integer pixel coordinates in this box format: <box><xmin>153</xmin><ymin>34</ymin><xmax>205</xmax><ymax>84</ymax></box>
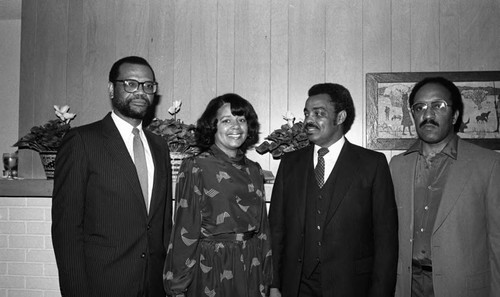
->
<box><xmin>270</xmin><ymin>83</ymin><xmax>398</xmax><ymax>297</ymax></box>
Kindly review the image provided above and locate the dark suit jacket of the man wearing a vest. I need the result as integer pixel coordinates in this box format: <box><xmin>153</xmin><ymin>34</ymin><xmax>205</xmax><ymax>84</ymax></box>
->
<box><xmin>269</xmin><ymin>141</ymin><xmax>398</xmax><ymax>297</ymax></box>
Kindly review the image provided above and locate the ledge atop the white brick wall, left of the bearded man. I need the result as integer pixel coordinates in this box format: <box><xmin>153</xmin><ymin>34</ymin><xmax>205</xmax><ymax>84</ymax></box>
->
<box><xmin>0</xmin><ymin>179</ymin><xmax>54</xmax><ymax>197</ymax></box>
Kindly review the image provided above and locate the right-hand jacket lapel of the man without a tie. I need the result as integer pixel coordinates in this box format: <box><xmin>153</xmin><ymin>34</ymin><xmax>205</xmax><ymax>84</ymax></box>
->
<box><xmin>433</xmin><ymin>141</ymin><xmax>470</xmax><ymax>233</ymax></box>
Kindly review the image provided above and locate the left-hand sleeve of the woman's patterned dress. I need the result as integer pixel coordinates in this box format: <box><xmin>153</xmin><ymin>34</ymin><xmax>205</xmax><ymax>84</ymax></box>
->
<box><xmin>163</xmin><ymin>158</ymin><xmax>203</xmax><ymax>295</ymax></box>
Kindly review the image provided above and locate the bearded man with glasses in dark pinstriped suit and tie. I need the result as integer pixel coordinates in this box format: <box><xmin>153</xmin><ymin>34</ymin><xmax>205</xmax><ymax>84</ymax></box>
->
<box><xmin>52</xmin><ymin>57</ymin><xmax>172</xmax><ymax>297</ymax></box>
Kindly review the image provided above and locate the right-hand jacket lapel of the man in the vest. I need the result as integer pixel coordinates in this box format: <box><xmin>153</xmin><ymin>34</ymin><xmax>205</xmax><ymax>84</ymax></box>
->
<box><xmin>325</xmin><ymin>140</ymin><xmax>360</xmax><ymax>225</ymax></box>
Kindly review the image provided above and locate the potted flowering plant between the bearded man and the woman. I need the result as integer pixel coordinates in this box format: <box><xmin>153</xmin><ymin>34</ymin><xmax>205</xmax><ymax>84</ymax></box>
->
<box><xmin>146</xmin><ymin>100</ymin><xmax>199</xmax><ymax>155</ymax></box>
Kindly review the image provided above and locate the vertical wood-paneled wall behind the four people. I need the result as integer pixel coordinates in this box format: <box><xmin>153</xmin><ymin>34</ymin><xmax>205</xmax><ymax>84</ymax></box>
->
<box><xmin>19</xmin><ymin>0</ymin><xmax>500</xmax><ymax>177</ymax></box>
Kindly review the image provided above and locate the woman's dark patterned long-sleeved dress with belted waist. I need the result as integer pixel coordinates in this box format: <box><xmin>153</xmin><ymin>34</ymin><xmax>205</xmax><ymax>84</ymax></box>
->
<box><xmin>163</xmin><ymin>145</ymin><xmax>272</xmax><ymax>297</ymax></box>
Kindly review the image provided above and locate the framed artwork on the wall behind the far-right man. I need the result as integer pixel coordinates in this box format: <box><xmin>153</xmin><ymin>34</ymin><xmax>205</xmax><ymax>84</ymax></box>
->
<box><xmin>366</xmin><ymin>71</ymin><xmax>500</xmax><ymax>150</ymax></box>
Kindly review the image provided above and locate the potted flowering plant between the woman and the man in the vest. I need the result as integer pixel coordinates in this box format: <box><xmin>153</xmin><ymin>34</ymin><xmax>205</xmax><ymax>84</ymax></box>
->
<box><xmin>256</xmin><ymin>111</ymin><xmax>309</xmax><ymax>159</ymax></box>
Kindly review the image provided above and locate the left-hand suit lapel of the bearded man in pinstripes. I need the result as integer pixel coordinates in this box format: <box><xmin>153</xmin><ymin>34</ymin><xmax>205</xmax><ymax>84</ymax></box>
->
<box><xmin>102</xmin><ymin>113</ymin><xmax>147</xmax><ymax>215</ymax></box>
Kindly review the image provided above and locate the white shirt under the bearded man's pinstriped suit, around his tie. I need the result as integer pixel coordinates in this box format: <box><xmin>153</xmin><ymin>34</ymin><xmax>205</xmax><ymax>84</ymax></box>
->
<box><xmin>111</xmin><ymin>111</ymin><xmax>155</xmax><ymax>211</ymax></box>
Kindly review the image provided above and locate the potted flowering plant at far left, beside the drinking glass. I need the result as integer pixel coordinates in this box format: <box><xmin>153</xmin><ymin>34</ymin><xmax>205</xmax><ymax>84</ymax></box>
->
<box><xmin>14</xmin><ymin>105</ymin><xmax>76</xmax><ymax>152</ymax></box>
